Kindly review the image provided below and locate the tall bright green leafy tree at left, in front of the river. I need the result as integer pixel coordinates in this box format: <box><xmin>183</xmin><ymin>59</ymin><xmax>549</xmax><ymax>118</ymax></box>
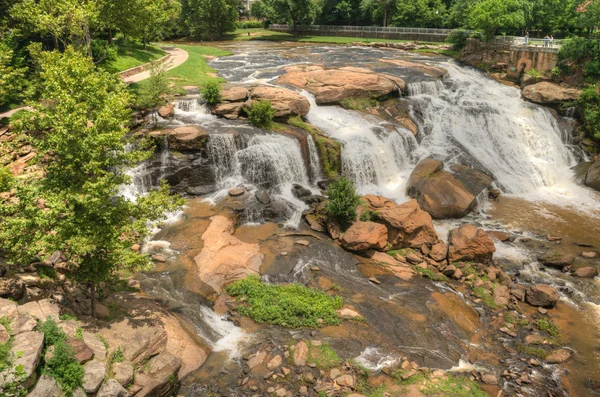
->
<box><xmin>0</xmin><ymin>47</ymin><xmax>181</xmax><ymax>315</ymax></box>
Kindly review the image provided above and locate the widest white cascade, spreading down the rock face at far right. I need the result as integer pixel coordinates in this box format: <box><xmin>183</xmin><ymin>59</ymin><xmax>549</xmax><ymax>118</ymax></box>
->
<box><xmin>409</xmin><ymin>63</ymin><xmax>597</xmax><ymax>210</ymax></box>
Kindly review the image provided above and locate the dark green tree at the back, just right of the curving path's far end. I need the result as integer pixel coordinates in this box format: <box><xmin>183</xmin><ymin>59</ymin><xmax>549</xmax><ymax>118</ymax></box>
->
<box><xmin>182</xmin><ymin>0</ymin><xmax>239</xmax><ymax>39</ymax></box>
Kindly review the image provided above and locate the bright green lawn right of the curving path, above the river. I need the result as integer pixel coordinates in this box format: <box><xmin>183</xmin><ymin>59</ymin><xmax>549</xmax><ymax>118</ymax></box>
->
<box><xmin>131</xmin><ymin>43</ymin><xmax>231</xmax><ymax>96</ymax></box>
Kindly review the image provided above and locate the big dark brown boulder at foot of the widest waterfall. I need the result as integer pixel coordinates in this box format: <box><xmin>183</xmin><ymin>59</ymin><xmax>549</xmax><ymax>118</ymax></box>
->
<box><xmin>407</xmin><ymin>159</ymin><xmax>492</xmax><ymax>219</ymax></box>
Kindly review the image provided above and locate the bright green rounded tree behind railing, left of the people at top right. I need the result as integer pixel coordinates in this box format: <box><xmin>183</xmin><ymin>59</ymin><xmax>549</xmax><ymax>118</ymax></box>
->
<box><xmin>469</xmin><ymin>0</ymin><xmax>525</xmax><ymax>40</ymax></box>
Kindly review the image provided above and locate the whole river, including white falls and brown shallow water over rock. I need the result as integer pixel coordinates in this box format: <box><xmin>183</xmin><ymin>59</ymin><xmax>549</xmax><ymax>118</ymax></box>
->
<box><xmin>132</xmin><ymin>41</ymin><xmax>600</xmax><ymax>396</ymax></box>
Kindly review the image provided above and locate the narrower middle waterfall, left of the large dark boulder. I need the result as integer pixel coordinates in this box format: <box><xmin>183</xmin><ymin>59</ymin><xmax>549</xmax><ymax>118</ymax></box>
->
<box><xmin>303</xmin><ymin>92</ymin><xmax>417</xmax><ymax>200</ymax></box>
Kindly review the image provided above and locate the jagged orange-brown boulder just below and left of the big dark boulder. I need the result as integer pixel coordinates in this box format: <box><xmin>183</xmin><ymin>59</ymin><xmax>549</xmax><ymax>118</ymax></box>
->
<box><xmin>363</xmin><ymin>195</ymin><xmax>438</xmax><ymax>249</ymax></box>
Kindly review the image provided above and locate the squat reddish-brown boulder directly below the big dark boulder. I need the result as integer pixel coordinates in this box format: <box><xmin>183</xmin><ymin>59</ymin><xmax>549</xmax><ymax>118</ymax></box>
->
<box><xmin>448</xmin><ymin>225</ymin><xmax>496</xmax><ymax>263</ymax></box>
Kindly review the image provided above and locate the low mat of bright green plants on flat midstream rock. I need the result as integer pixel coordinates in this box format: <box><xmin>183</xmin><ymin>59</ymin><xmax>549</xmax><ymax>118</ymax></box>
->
<box><xmin>227</xmin><ymin>276</ymin><xmax>342</xmax><ymax>328</ymax></box>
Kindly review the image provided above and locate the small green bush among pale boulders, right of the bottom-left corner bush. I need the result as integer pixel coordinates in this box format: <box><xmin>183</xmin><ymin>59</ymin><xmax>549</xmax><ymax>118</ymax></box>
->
<box><xmin>44</xmin><ymin>341</ymin><xmax>84</xmax><ymax>395</ymax></box>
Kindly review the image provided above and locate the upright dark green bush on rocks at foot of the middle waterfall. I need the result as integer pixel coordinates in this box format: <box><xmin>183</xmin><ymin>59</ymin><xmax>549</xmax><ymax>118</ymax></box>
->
<box><xmin>325</xmin><ymin>177</ymin><xmax>361</xmax><ymax>229</ymax></box>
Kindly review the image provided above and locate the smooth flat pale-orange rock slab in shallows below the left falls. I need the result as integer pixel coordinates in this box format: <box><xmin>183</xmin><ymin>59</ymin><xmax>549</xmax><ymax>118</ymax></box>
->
<box><xmin>194</xmin><ymin>215</ymin><xmax>264</xmax><ymax>294</ymax></box>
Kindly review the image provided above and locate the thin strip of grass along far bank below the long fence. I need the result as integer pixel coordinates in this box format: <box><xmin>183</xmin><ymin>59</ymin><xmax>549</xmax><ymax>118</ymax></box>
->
<box><xmin>225</xmin><ymin>28</ymin><xmax>444</xmax><ymax>45</ymax></box>
